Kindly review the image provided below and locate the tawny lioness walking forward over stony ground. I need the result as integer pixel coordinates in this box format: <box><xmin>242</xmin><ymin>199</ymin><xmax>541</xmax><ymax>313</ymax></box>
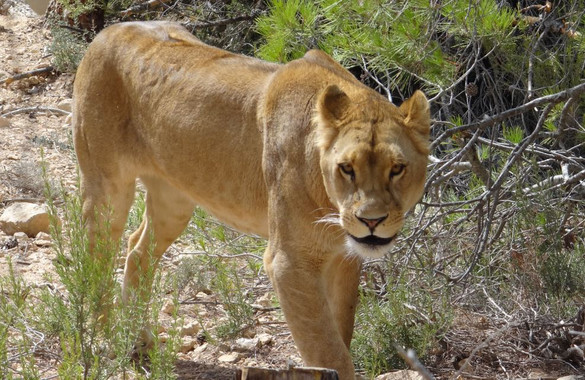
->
<box><xmin>73</xmin><ymin>22</ymin><xmax>430</xmax><ymax>379</ymax></box>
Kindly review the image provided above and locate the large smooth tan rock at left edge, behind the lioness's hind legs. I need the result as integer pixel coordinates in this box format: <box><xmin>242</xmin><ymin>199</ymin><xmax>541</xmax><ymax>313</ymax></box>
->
<box><xmin>0</xmin><ymin>202</ymin><xmax>49</xmax><ymax>237</ymax></box>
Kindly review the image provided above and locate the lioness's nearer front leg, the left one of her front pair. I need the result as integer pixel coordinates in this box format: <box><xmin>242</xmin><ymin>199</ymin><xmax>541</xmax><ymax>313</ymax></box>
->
<box><xmin>264</xmin><ymin>244</ymin><xmax>354</xmax><ymax>380</ymax></box>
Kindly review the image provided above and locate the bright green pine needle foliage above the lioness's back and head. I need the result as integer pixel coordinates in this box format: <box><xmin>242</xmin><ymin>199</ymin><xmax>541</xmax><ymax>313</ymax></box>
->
<box><xmin>257</xmin><ymin>0</ymin><xmax>515</xmax><ymax>91</ymax></box>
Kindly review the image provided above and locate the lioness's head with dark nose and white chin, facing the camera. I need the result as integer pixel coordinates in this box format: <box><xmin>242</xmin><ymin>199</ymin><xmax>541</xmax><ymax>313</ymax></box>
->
<box><xmin>315</xmin><ymin>85</ymin><xmax>430</xmax><ymax>257</ymax></box>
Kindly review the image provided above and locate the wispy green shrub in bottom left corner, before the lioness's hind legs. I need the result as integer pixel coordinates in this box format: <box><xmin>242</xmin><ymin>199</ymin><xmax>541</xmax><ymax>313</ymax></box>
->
<box><xmin>0</xmin><ymin>160</ymin><xmax>179</xmax><ymax>380</ymax></box>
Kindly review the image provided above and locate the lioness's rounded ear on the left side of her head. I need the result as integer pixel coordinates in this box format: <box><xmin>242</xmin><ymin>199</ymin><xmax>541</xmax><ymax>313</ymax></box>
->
<box><xmin>314</xmin><ymin>84</ymin><xmax>350</xmax><ymax>150</ymax></box>
